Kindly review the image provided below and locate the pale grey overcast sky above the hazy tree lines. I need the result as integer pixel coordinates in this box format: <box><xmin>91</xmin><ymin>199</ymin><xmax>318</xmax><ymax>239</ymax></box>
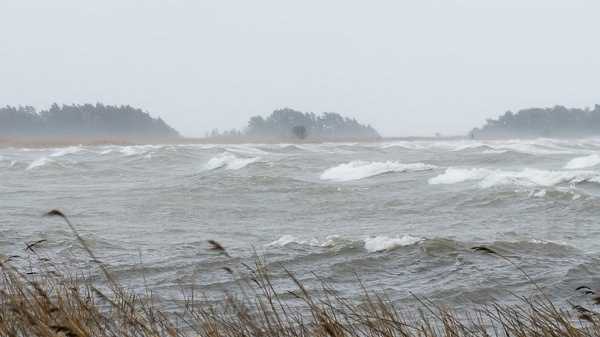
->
<box><xmin>0</xmin><ymin>0</ymin><xmax>600</xmax><ymax>136</ymax></box>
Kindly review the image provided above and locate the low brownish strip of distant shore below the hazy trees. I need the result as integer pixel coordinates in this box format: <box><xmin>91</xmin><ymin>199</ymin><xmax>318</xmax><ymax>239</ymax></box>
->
<box><xmin>0</xmin><ymin>136</ymin><xmax>467</xmax><ymax>149</ymax></box>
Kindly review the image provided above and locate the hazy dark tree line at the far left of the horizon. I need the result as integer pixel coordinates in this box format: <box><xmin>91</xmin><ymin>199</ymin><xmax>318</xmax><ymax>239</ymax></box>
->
<box><xmin>0</xmin><ymin>103</ymin><xmax>179</xmax><ymax>138</ymax></box>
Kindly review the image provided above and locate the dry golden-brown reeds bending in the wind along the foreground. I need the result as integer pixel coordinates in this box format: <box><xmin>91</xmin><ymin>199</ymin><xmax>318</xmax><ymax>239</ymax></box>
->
<box><xmin>0</xmin><ymin>211</ymin><xmax>600</xmax><ymax>337</ymax></box>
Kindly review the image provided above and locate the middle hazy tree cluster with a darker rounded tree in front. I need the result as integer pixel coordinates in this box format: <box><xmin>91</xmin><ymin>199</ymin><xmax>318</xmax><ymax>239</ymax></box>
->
<box><xmin>246</xmin><ymin>108</ymin><xmax>379</xmax><ymax>139</ymax></box>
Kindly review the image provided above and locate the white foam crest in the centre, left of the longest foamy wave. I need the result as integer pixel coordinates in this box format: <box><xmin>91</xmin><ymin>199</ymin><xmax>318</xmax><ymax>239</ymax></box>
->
<box><xmin>321</xmin><ymin>160</ymin><xmax>436</xmax><ymax>181</ymax></box>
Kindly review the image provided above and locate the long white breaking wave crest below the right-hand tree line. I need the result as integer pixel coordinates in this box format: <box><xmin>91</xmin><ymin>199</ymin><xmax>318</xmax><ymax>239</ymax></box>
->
<box><xmin>429</xmin><ymin>168</ymin><xmax>600</xmax><ymax>188</ymax></box>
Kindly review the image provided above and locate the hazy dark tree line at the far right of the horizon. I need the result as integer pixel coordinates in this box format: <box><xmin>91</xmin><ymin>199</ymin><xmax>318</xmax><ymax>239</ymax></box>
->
<box><xmin>470</xmin><ymin>104</ymin><xmax>600</xmax><ymax>138</ymax></box>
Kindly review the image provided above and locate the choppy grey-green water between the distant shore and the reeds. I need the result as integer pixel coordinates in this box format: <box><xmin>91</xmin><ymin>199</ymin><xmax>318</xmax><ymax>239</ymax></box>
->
<box><xmin>0</xmin><ymin>139</ymin><xmax>600</xmax><ymax>307</ymax></box>
